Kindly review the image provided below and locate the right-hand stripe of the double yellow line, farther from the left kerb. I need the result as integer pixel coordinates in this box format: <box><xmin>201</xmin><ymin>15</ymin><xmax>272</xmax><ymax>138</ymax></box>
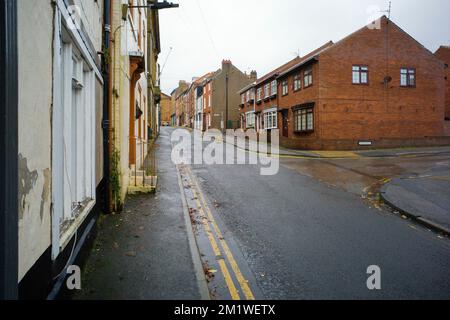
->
<box><xmin>187</xmin><ymin>168</ymin><xmax>255</xmax><ymax>300</ymax></box>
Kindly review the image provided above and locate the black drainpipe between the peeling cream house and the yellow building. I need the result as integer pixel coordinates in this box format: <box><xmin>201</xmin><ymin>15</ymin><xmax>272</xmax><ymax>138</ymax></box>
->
<box><xmin>102</xmin><ymin>0</ymin><xmax>112</xmax><ymax>213</ymax></box>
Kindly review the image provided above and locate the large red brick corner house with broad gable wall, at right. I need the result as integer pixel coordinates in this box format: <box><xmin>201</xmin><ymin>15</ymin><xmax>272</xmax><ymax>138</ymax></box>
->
<box><xmin>237</xmin><ymin>17</ymin><xmax>450</xmax><ymax>150</ymax></box>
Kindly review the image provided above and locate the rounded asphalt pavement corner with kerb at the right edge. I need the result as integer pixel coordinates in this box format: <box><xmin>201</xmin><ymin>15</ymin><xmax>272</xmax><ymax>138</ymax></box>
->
<box><xmin>381</xmin><ymin>170</ymin><xmax>450</xmax><ymax>235</ymax></box>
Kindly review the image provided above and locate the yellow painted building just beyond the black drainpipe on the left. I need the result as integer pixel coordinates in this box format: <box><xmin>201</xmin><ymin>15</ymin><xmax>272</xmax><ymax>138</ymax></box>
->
<box><xmin>110</xmin><ymin>0</ymin><xmax>160</xmax><ymax>211</ymax></box>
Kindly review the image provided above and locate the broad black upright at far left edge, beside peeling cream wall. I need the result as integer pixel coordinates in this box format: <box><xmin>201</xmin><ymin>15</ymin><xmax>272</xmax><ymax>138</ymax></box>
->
<box><xmin>0</xmin><ymin>0</ymin><xmax>19</xmax><ymax>300</ymax></box>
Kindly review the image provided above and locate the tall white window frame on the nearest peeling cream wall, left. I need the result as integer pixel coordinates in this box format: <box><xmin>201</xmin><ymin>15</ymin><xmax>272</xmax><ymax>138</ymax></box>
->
<box><xmin>51</xmin><ymin>4</ymin><xmax>103</xmax><ymax>260</ymax></box>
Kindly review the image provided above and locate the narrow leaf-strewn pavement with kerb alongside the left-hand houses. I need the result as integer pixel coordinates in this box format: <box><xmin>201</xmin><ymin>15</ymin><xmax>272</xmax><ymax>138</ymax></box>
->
<box><xmin>73</xmin><ymin>127</ymin><xmax>209</xmax><ymax>300</ymax></box>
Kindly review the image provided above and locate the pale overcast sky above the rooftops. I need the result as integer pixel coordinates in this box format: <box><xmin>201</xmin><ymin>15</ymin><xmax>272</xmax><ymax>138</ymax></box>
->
<box><xmin>159</xmin><ymin>0</ymin><xmax>450</xmax><ymax>94</ymax></box>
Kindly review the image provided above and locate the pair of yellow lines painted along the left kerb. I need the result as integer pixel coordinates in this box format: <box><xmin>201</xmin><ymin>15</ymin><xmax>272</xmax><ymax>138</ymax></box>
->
<box><xmin>186</xmin><ymin>167</ymin><xmax>255</xmax><ymax>300</ymax></box>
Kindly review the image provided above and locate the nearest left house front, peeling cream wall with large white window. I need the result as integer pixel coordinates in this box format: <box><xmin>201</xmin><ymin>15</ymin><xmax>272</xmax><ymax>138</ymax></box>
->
<box><xmin>12</xmin><ymin>0</ymin><xmax>105</xmax><ymax>298</ymax></box>
